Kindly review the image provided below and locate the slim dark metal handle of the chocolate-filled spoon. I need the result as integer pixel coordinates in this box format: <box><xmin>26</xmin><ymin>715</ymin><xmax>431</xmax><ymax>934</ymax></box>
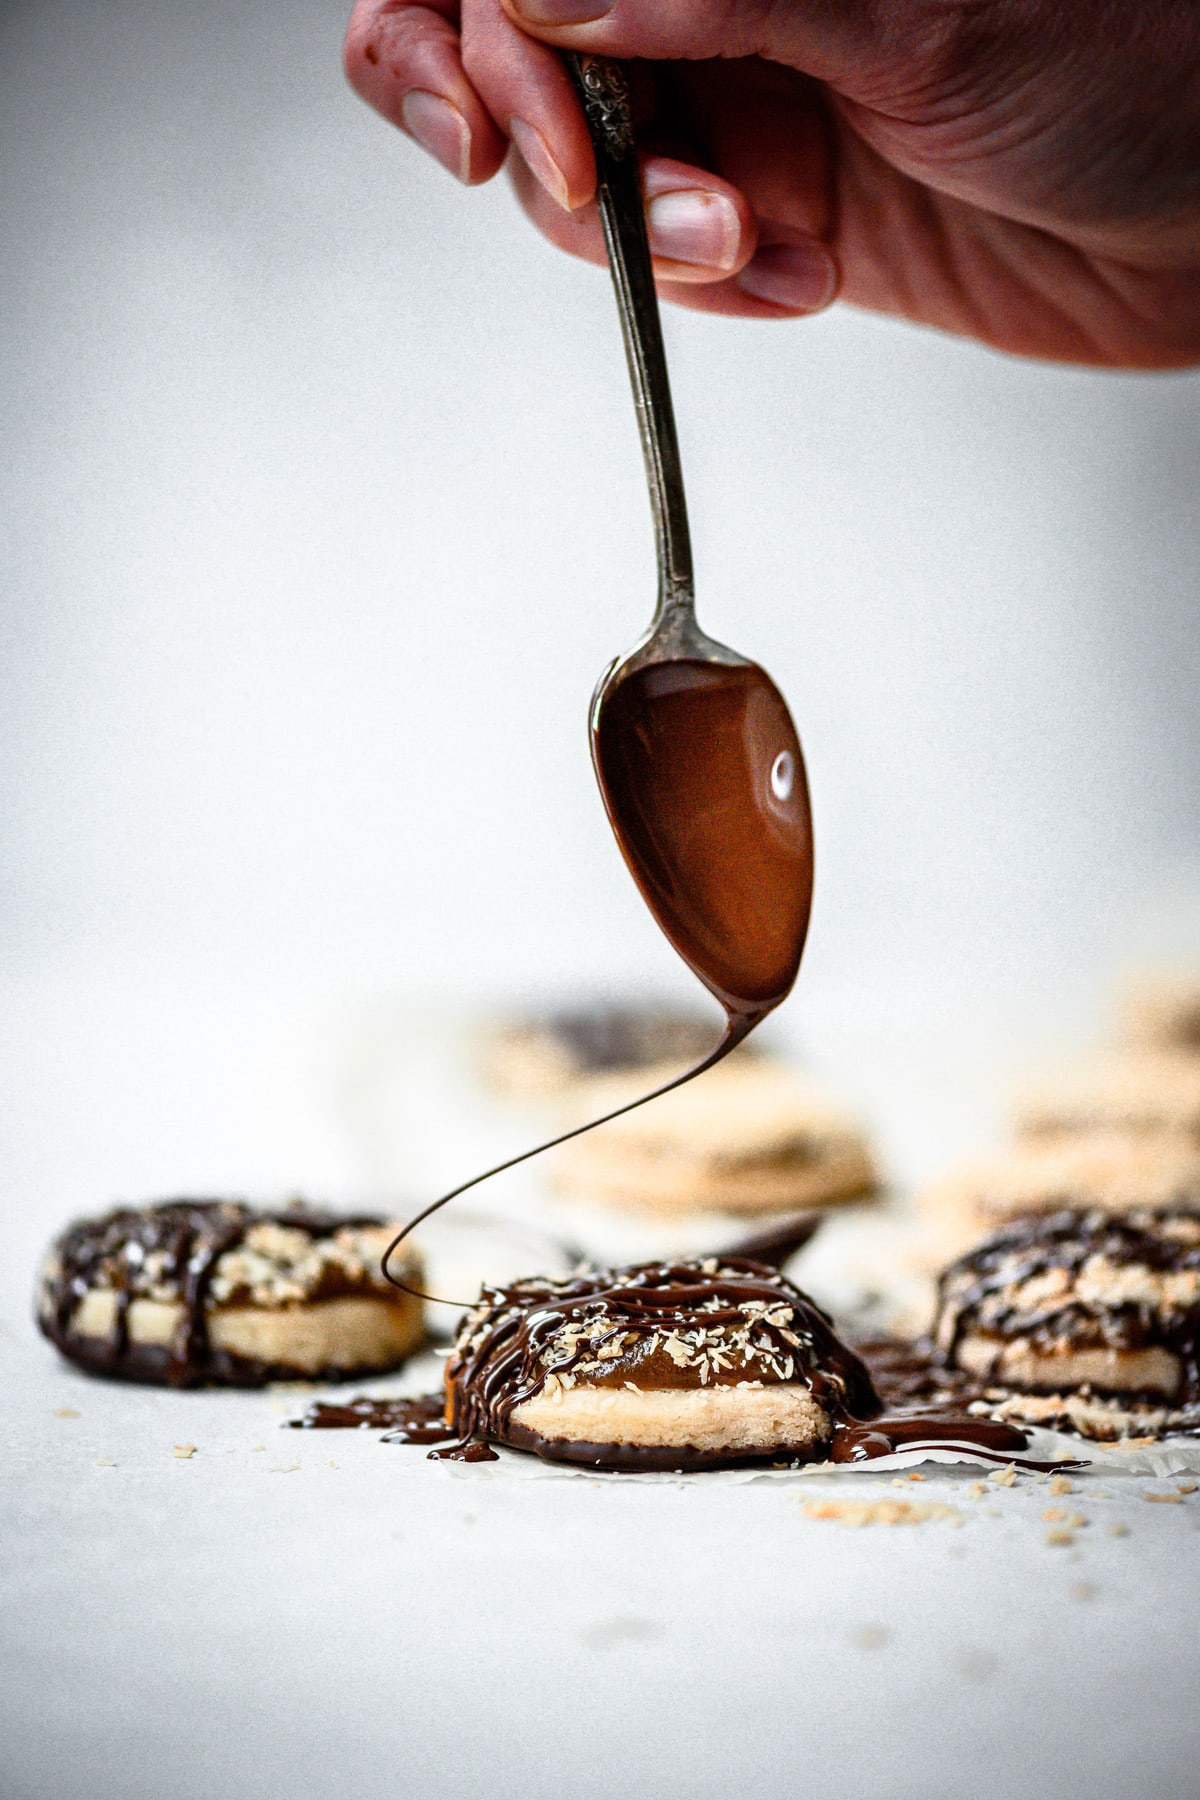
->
<box><xmin>567</xmin><ymin>52</ymin><xmax>694</xmax><ymax>625</ymax></box>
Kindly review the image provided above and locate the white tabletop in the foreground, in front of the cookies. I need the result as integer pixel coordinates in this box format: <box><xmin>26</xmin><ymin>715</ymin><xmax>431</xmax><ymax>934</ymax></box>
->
<box><xmin>0</xmin><ymin>1318</ymin><xmax>1200</xmax><ymax>1800</ymax></box>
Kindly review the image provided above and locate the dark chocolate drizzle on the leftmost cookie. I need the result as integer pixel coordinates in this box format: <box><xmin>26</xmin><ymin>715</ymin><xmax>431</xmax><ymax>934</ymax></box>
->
<box><xmin>38</xmin><ymin>1201</ymin><xmax>385</xmax><ymax>1388</ymax></box>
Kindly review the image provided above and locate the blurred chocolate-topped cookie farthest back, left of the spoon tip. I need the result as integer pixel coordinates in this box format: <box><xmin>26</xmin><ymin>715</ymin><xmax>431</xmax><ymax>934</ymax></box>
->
<box><xmin>480</xmin><ymin>1001</ymin><xmax>750</xmax><ymax>1102</ymax></box>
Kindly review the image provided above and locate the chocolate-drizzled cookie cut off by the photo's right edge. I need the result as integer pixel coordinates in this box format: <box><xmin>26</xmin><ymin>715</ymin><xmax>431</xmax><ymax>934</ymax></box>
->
<box><xmin>934</xmin><ymin>1210</ymin><xmax>1200</xmax><ymax>1406</ymax></box>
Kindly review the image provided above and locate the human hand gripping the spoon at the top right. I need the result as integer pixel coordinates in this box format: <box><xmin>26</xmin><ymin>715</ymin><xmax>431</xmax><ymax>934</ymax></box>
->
<box><xmin>345</xmin><ymin>0</ymin><xmax>1200</xmax><ymax>369</ymax></box>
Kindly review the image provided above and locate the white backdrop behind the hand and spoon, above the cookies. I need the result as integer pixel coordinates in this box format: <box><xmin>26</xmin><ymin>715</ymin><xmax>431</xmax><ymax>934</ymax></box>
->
<box><xmin>0</xmin><ymin>0</ymin><xmax>1200</xmax><ymax>1238</ymax></box>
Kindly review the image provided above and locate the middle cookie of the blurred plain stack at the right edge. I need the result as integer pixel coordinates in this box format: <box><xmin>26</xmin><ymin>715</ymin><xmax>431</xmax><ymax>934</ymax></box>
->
<box><xmin>1015</xmin><ymin>1051</ymin><xmax>1200</xmax><ymax>1145</ymax></box>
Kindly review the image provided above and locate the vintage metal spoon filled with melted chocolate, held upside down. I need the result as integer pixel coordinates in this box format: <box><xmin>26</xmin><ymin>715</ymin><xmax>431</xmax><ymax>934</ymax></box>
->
<box><xmin>567</xmin><ymin>54</ymin><xmax>813</xmax><ymax>1053</ymax></box>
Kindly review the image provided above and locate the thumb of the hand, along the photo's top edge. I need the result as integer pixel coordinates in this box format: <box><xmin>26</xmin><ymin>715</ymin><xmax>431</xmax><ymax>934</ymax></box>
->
<box><xmin>502</xmin><ymin>0</ymin><xmax>892</xmax><ymax>86</ymax></box>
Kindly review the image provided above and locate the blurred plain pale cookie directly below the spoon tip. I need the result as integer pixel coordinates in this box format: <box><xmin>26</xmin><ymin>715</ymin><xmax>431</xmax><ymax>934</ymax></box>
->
<box><xmin>551</xmin><ymin>1057</ymin><xmax>878</xmax><ymax>1217</ymax></box>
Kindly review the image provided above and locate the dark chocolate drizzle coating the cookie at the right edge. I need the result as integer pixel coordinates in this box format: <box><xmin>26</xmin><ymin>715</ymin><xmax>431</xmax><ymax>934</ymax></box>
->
<box><xmin>936</xmin><ymin>1210</ymin><xmax>1200</xmax><ymax>1406</ymax></box>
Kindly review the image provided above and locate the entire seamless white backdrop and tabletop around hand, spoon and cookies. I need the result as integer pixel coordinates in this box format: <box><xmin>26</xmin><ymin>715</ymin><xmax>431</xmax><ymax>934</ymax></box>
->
<box><xmin>0</xmin><ymin>0</ymin><xmax>1200</xmax><ymax>1800</ymax></box>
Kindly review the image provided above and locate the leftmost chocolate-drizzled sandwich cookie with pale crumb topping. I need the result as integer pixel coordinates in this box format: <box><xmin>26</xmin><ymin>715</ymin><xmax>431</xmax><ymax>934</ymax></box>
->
<box><xmin>38</xmin><ymin>1201</ymin><xmax>425</xmax><ymax>1388</ymax></box>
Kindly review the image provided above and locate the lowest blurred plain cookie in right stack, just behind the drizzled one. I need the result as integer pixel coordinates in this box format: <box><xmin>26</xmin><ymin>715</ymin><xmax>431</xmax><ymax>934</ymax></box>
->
<box><xmin>914</xmin><ymin>1130</ymin><xmax>1200</xmax><ymax>1265</ymax></box>
